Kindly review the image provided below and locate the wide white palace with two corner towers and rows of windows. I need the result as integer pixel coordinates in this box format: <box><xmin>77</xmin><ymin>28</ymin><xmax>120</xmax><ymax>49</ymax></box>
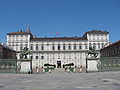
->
<box><xmin>7</xmin><ymin>27</ymin><xmax>109</xmax><ymax>68</ymax></box>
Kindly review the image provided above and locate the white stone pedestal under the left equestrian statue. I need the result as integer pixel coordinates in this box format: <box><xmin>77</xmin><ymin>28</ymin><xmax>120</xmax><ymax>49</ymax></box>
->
<box><xmin>20</xmin><ymin>60</ymin><xmax>32</xmax><ymax>74</ymax></box>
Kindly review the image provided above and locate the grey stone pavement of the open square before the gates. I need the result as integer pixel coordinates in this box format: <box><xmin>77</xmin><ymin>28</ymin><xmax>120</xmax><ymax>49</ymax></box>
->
<box><xmin>0</xmin><ymin>72</ymin><xmax>120</xmax><ymax>90</ymax></box>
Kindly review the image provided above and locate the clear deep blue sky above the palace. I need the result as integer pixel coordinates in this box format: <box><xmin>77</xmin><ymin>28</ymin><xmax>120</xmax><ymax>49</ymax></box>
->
<box><xmin>0</xmin><ymin>0</ymin><xmax>120</xmax><ymax>42</ymax></box>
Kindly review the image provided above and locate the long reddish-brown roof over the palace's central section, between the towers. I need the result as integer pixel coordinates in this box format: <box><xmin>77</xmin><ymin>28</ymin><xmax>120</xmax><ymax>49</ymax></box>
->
<box><xmin>31</xmin><ymin>37</ymin><xmax>87</xmax><ymax>41</ymax></box>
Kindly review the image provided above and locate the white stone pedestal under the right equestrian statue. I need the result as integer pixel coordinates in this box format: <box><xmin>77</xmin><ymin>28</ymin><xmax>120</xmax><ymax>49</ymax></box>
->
<box><xmin>86</xmin><ymin>58</ymin><xmax>98</xmax><ymax>72</ymax></box>
